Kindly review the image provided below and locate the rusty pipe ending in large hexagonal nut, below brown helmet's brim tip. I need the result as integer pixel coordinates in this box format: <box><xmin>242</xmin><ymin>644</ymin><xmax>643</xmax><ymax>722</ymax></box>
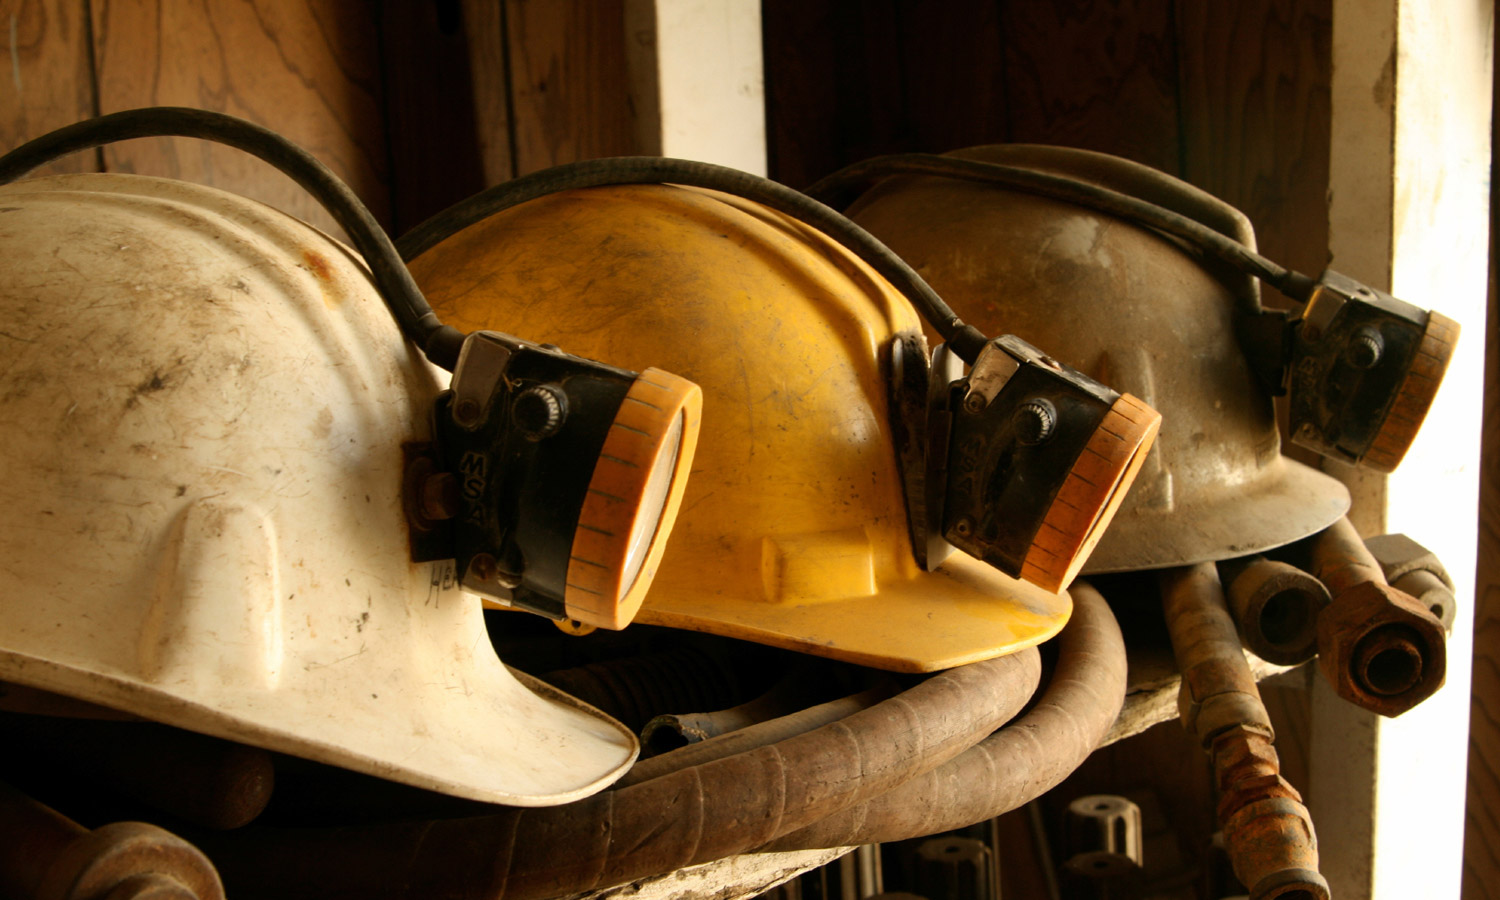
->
<box><xmin>1308</xmin><ymin>519</ymin><xmax>1448</xmax><ymax>717</ymax></box>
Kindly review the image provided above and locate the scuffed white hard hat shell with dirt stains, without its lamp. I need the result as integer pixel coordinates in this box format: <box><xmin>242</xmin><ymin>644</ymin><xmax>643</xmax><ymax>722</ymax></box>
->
<box><xmin>0</xmin><ymin>176</ymin><xmax>636</xmax><ymax>806</ymax></box>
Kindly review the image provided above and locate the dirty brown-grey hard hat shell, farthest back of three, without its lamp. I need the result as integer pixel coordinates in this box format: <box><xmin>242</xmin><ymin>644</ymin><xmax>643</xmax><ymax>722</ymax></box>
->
<box><xmin>849</xmin><ymin>146</ymin><xmax>1349</xmax><ymax>572</ymax></box>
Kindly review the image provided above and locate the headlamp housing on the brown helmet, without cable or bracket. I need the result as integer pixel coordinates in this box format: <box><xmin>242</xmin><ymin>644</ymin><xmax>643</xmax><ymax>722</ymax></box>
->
<box><xmin>1286</xmin><ymin>272</ymin><xmax>1458</xmax><ymax>473</ymax></box>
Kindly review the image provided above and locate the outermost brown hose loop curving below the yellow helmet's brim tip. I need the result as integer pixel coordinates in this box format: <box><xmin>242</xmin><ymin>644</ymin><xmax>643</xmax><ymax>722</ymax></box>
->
<box><xmin>759</xmin><ymin>582</ymin><xmax>1125</xmax><ymax>851</ymax></box>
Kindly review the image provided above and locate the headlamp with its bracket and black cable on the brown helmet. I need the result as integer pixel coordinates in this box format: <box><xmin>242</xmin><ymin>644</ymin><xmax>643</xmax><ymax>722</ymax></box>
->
<box><xmin>807</xmin><ymin>153</ymin><xmax>1458</xmax><ymax>473</ymax></box>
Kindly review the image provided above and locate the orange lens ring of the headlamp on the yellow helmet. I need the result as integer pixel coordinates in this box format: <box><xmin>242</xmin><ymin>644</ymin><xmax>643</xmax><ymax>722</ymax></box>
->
<box><xmin>1020</xmin><ymin>393</ymin><xmax>1161</xmax><ymax>591</ymax></box>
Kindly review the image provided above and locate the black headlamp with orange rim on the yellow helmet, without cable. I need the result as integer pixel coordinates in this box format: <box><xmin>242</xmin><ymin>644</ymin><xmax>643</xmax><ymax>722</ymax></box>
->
<box><xmin>891</xmin><ymin>328</ymin><xmax>1161</xmax><ymax>591</ymax></box>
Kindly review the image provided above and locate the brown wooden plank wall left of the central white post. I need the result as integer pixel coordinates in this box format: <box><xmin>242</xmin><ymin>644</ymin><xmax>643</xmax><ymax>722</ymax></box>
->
<box><xmin>0</xmin><ymin>0</ymin><xmax>633</xmax><ymax>234</ymax></box>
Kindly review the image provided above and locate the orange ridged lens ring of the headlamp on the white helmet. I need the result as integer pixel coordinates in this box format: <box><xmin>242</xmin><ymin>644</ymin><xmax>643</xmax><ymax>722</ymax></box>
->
<box><xmin>563</xmin><ymin>369</ymin><xmax>704</xmax><ymax>629</ymax></box>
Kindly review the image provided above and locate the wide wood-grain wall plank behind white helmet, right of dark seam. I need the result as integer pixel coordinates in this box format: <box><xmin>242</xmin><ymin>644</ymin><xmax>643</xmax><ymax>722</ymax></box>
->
<box><xmin>93</xmin><ymin>0</ymin><xmax>390</xmax><ymax>234</ymax></box>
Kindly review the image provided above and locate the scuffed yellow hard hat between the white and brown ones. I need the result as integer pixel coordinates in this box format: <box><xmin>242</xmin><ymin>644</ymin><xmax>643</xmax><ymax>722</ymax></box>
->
<box><xmin>411</xmin><ymin>185</ymin><xmax>1071</xmax><ymax>672</ymax></box>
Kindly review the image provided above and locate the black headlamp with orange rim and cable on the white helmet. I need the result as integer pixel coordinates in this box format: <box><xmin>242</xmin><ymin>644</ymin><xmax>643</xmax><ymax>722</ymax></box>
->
<box><xmin>0</xmin><ymin>107</ymin><xmax>699</xmax><ymax>629</ymax></box>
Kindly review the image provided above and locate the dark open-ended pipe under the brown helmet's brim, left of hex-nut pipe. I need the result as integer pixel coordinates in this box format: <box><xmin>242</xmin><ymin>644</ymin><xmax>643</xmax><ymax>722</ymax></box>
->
<box><xmin>1218</xmin><ymin>557</ymin><xmax>1329</xmax><ymax>666</ymax></box>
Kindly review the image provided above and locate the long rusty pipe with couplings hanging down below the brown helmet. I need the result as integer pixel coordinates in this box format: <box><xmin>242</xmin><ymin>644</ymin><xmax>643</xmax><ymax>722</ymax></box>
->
<box><xmin>1158</xmin><ymin>563</ymin><xmax>1329</xmax><ymax>900</ymax></box>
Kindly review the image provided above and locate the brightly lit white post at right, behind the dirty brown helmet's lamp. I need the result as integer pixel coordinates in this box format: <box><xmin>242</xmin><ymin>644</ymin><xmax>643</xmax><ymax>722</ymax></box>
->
<box><xmin>1310</xmin><ymin>0</ymin><xmax>1494</xmax><ymax>900</ymax></box>
